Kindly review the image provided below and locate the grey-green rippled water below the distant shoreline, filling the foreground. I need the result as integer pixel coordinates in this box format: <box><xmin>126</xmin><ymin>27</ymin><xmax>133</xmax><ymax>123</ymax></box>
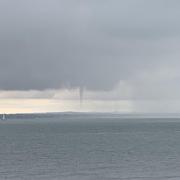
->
<box><xmin>0</xmin><ymin>118</ymin><xmax>180</xmax><ymax>180</ymax></box>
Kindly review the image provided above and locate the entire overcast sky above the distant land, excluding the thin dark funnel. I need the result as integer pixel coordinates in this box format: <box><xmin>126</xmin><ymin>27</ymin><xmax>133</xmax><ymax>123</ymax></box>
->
<box><xmin>0</xmin><ymin>0</ymin><xmax>180</xmax><ymax>112</ymax></box>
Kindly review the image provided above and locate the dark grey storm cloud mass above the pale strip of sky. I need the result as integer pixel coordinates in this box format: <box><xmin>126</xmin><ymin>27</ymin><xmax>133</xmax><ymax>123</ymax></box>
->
<box><xmin>0</xmin><ymin>0</ymin><xmax>180</xmax><ymax>94</ymax></box>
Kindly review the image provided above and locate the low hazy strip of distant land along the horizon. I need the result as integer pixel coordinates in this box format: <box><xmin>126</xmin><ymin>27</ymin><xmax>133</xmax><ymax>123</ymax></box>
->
<box><xmin>0</xmin><ymin>112</ymin><xmax>180</xmax><ymax>119</ymax></box>
